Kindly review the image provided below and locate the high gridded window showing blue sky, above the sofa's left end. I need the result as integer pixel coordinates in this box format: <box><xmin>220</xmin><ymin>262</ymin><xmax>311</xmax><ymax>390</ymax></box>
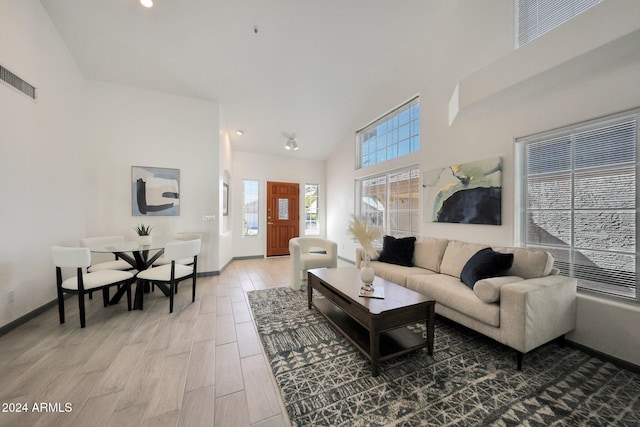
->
<box><xmin>356</xmin><ymin>97</ymin><xmax>420</xmax><ymax>168</ymax></box>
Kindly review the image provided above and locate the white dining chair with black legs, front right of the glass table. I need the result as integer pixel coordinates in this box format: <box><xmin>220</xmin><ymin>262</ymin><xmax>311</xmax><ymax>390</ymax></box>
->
<box><xmin>137</xmin><ymin>239</ymin><xmax>201</xmax><ymax>313</ymax></box>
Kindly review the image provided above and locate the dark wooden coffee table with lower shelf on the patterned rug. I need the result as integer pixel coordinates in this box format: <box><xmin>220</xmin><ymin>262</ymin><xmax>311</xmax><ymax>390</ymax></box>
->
<box><xmin>307</xmin><ymin>267</ymin><xmax>435</xmax><ymax>377</ymax></box>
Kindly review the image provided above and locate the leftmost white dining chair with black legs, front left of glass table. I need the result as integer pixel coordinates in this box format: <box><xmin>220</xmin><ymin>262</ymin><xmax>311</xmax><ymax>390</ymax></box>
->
<box><xmin>51</xmin><ymin>246</ymin><xmax>135</xmax><ymax>328</ymax></box>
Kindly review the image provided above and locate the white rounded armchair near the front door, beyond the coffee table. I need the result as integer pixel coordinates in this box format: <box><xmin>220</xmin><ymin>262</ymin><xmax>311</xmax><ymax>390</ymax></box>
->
<box><xmin>289</xmin><ymin>237</ymin><xmax>338</xmax><ymax>291</ymax></box>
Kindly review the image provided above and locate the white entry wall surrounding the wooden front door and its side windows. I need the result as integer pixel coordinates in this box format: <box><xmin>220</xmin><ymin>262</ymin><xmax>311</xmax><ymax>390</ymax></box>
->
<box><xmin>229</xmin><ymin>152</ymin><xmax>328</xmax><ymax>257</ymax></box>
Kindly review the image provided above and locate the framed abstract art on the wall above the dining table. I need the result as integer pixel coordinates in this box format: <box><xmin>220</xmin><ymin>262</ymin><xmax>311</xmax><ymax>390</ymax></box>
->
<box><xmin>131</xmin><ymin>166</ymin><xmax>180</xmax><ymax>216</ymax></box>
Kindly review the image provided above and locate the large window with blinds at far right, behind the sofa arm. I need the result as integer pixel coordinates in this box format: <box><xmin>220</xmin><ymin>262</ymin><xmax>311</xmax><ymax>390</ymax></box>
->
<box><xmin>516</xmin><ymin>110</ymin><xmax>640</xmax><ymax>301</ymax></box>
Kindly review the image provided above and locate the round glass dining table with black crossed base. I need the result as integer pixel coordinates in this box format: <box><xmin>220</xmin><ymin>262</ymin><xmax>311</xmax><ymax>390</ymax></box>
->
<box><xmin>91</xmin><ymin>238</ymin><xmax>175</xmax><ymax>310</ymax></box>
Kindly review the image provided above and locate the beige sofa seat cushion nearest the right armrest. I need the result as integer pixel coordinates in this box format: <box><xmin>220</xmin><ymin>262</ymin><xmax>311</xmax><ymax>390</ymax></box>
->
<box><xmin>407</xmin><ymin>274</ymin><xmax>500</xmax><ymax>327</ymax></box>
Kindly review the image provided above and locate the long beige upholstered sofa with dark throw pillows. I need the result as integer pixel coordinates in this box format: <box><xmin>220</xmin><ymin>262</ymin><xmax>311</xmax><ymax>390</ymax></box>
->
<box><xmin>356</xmin><ymin>237</ymin><xmax>576</xmax><ymax>369</ymax></box>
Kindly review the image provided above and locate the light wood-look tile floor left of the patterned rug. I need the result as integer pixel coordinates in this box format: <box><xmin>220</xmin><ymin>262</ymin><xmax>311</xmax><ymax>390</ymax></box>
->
<box><xmin>0</xmin><ymin>257</ymin><xmax>300</xmax><ymax>427</ymax></box>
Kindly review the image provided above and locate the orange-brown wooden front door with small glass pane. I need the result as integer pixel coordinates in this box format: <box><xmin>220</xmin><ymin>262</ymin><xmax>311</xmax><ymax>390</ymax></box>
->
<box><xmin>267</xmin><ymin>182</ymin><xmax>300</xmax><ymax>256</ymax></box>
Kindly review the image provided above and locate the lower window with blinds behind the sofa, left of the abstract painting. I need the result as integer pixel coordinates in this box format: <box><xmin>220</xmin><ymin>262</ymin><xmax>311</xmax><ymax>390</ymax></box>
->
<box><xmin>357</xmin><ymin>166</ymin><xmax>420</xmax><ymax>236</ymax></box>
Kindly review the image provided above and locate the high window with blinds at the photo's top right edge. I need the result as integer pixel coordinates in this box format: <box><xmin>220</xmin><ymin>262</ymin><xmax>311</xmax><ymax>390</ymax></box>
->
<box><xmin>514</xmin><ymin>0</ymin><xmax>602</xmax><ymax>48</ymax></box>
